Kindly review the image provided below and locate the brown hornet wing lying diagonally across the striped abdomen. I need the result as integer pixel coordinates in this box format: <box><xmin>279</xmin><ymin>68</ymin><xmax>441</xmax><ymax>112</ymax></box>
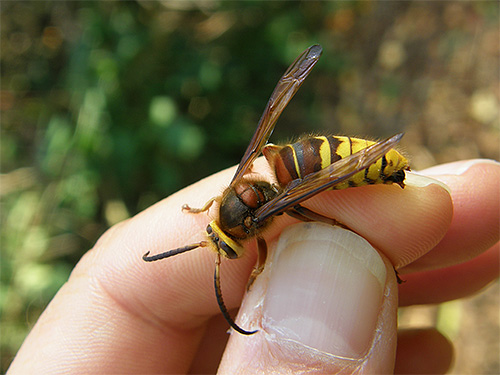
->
<box><xmin>254</xmin><ymin>133</ymin><xmax>403</xmax><ymax>222</ymax></box>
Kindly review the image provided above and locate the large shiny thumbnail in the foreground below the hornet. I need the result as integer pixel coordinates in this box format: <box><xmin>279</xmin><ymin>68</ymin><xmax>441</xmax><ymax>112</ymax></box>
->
<box><xmin>262</xmin><ymin>223</ymin><xmax>386</xmax><ymax>358</ymax></box>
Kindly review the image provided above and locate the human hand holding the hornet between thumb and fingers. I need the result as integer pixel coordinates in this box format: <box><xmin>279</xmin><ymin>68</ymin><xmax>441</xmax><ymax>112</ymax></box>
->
<box><xmin>9</xmin><ymin>160</ymin><xmax>500</xmax><ymax>374</ymax></box>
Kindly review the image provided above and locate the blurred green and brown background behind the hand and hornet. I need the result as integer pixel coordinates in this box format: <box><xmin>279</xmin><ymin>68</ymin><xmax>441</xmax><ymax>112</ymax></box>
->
<box><xmin>0</xmin><ymin>0</ymin><xmax>500</xmax><ymax>373</ymax></box>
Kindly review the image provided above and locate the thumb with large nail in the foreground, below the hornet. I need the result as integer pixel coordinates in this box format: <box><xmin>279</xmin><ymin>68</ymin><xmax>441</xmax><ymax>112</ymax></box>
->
<box><xmin>219</xmin><ymin>223</ymin><xmax>397</xmax><ymax>374</ymax></box>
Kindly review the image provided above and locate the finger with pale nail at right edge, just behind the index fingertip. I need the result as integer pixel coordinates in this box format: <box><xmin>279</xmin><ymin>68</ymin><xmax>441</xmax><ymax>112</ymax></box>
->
<box><xmin>401</xmin><ymin>159</ymin><xmax>500</xmax><ymax>273</ymax></box>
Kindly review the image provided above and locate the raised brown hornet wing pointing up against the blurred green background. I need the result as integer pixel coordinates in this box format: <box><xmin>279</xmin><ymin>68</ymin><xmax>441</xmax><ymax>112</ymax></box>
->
<box><xmin>231</xmin><ymin>45</ymin><xmax>323</xmax><ymax>186</ymax></box>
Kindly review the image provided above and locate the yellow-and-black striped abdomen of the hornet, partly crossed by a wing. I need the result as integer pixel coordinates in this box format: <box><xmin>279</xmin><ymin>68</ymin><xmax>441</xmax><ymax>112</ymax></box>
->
<box><xmin>262</xmin><ymin>136</ymin><xmax>409</xmax><ymax>189</ymax></box>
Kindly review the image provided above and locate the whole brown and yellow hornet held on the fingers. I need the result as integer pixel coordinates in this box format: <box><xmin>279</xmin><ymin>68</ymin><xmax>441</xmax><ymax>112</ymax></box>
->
<box><xmin>142</xmin><ymin>45</ymin><xmax>409</xmax><ymax>335</ymax></box>
